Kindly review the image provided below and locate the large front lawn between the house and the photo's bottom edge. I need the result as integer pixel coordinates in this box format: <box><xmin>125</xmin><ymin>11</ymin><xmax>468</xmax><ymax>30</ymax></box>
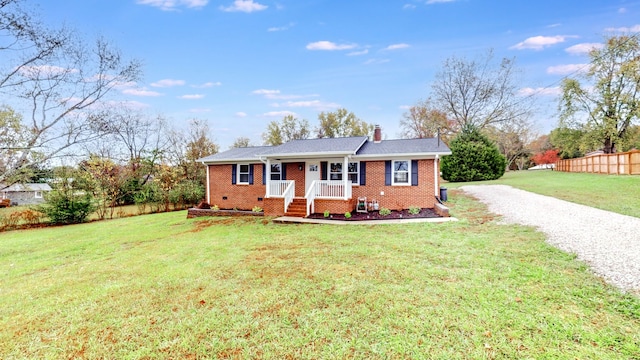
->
<box><xmin>0</xmin><ymin>198</ymin><xmax>640</xmax><ymax>359</ymax></box>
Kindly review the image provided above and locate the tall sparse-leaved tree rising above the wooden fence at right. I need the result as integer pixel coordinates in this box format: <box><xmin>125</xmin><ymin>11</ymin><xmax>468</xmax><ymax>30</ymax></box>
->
<box><xmin>559</xmin><ymin>35</ymin><xmax>640</xmax><ymax>154</ymax></box>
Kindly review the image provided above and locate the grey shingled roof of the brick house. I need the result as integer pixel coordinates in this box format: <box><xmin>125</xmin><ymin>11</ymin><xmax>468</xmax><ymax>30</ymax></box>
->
<box><xmin>198</xmin><ymin>136</ymin><xmax>451</xmax><ymax>164</ymax></box>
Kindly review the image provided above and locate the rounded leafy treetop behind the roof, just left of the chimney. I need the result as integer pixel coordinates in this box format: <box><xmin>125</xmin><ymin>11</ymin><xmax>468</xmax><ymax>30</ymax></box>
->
<box><xmin>316</xmin><ymin>109</ymin><xmax>375</xmax><ymax>138</ymax></box>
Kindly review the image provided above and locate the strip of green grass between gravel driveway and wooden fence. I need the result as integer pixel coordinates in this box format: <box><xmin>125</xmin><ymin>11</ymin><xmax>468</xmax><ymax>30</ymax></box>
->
<box><xmin>443</xmin><ymin>170</ymin><xmax>640</xmax><ymax>217</ymax></box>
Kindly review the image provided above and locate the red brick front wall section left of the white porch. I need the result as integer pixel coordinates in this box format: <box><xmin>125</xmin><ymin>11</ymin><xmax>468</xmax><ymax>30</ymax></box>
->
<box><xmin>208</xmin><ymin>163</ymin><xmax>266</xmax><ymax>210</ymax></box>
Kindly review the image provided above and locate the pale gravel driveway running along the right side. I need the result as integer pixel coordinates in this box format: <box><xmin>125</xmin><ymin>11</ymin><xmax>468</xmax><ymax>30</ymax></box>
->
<box><xmin>460</xmin><ymin>185</ymin><xmax>640</xmax><ymax>293</ymax></box>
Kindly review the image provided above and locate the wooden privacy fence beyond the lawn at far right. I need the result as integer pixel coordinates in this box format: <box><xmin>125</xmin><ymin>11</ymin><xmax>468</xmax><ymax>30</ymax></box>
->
<box><xmin>556</xmin><ymin>150</ymin><xmax>640</xmax><ymax>175</ymax></box>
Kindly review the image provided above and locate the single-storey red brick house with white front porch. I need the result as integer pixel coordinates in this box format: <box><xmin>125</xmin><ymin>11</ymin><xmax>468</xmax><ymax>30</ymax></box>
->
<box><xmin>199</xmin><ymin>127</ymin><xmax>451</xmax><ymax>217</ymax></box>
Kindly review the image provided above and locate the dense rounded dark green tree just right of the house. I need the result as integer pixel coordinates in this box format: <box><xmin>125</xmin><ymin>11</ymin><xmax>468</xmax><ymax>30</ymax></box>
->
<box><xmin>441</xmin><ymin>125</ymin><xmax>507</xmax><ymax>182</ymax></box>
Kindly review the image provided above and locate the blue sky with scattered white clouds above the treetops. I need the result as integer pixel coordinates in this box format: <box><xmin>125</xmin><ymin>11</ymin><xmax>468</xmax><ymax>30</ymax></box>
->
<box><xmin>32</xmin><ymin>0</ymin><xmax>640</xmax><ymax>149</ymax></box>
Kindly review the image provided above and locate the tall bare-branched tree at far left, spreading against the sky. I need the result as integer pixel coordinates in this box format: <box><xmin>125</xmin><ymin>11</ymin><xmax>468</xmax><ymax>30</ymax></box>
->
<box><xmin>0</xmin><ymin>0</ymin><xmax>141</xmax><ymax>184</ymax></box>
